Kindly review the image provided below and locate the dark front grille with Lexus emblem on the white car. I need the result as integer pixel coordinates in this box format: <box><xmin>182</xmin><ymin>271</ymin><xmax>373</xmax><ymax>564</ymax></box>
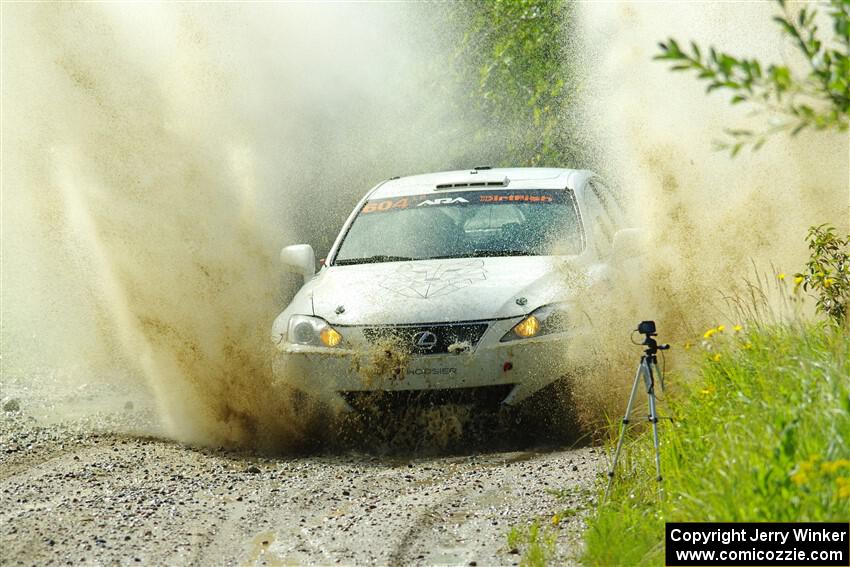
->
<box><xmin>363</xmin><ymin>323</ymin><xmax>487</xmax><ymax>355</ymax></box>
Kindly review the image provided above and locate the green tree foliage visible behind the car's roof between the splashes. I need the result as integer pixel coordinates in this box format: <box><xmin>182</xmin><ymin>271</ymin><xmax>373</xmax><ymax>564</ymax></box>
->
<box><xmin>449</xmin><ymin>0</ymin><xmax>580</xmax><ymax>166</ymax></box>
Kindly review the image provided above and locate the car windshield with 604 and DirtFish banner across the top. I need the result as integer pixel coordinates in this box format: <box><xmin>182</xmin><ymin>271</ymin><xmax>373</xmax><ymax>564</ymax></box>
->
<box><xmin>334</xmin><ymin>190</ymin><xmax>584</xmax><ymax>265</ymax></box>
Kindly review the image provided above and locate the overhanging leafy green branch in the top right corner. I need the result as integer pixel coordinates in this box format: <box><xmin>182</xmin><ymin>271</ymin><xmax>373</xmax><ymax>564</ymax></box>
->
<box><xmin>655</xmin><ymin>0</ymin><xmax>850</xmax><ymax>156</ymax></box>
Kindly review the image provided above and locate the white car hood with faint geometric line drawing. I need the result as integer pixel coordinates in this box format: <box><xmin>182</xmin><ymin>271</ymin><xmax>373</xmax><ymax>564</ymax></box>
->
<box><xmin>312</xmin><ymin>256</ymin><xmax>576</xmax><ymax>325</ymax></box>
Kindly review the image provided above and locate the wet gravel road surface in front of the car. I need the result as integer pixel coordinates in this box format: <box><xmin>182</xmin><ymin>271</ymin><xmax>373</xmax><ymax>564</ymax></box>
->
<box><xmin>0</xmin><ymin>382</ymin><xmax>602</xmax><ymax>565</ymax></box>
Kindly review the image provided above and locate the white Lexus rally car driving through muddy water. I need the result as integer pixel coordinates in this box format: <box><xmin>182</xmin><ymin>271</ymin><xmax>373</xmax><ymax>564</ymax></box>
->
<box><xmin>272</xmin><ymin>167</ymin><xmax>634</xmax><ymax>418</ymax></box>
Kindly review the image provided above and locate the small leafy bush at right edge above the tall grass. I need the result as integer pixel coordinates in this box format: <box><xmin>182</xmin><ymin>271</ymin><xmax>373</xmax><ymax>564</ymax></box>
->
<box><xmin>796</xmin><ymin>225</ymin><xmax>850</xmax><ymax>325</ymax></box>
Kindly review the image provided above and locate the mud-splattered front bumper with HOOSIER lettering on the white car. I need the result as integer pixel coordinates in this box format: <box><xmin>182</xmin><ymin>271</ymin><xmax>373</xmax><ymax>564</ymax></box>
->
<box><xmin>274</xmin><ymin>318</ymin><xmax>569</xmax><ymax>411</ymax></box>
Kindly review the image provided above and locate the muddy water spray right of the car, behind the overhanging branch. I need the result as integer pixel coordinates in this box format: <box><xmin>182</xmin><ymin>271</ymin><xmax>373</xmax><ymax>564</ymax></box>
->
<box><xmin>577</xmin><ymin>2</ymin><xmax>850</xmax><ymax>421</ymax></box>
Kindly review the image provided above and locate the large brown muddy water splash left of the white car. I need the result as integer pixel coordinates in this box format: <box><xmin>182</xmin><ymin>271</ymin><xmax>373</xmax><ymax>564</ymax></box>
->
<box><xmin>3</xmin><ymin>4</ymin><xmax>468</xmax><ymax>447</ymax></box>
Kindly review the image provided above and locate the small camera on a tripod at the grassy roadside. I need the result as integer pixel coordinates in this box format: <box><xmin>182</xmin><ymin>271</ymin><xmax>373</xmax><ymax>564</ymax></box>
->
<box><xmin>605</xmin><ymin>321</ymin><xmax>670</xmax><ymax>500</ymax></box>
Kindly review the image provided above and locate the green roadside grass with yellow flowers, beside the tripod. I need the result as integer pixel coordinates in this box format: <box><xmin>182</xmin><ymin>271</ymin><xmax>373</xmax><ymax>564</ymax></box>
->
<box><xmin>582</xmin><ymin>323</ymin><xmax>850</xmax><ymax>566</ymax></box>
